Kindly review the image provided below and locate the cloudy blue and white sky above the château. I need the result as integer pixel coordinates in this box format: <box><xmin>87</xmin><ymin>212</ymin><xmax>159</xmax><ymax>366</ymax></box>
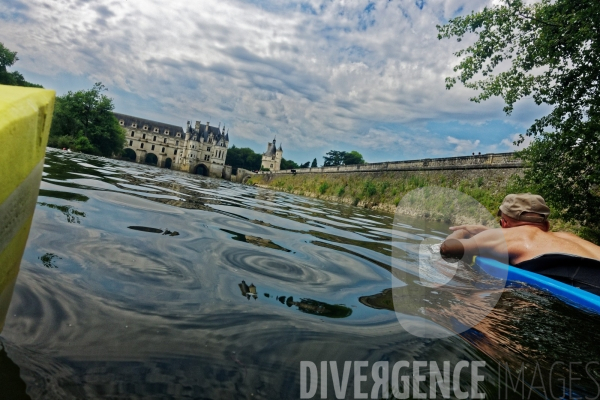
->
<box><xmin>0</xmin><ymin>0</ymin><xmax>543</xmax><ymax>164</ymax></box>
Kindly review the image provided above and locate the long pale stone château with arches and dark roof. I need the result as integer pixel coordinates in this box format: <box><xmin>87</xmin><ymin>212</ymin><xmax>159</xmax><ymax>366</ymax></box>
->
<box><xmin>114</xmin><ymin>113</ymin><xmax>230</xmax><ymax>177</ymax></box>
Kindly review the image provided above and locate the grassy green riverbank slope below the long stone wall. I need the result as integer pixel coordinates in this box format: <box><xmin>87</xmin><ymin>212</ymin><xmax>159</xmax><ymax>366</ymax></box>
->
<box><xmin>248</xmin><ymin>169</ymin><xmax>600</xmax><ymax>243</ymax></box>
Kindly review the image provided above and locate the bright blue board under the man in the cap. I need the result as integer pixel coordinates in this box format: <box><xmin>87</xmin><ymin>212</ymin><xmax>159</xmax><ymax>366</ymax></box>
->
<box><xmin>476</xmin><ymin>257</ymin><xmax>600</xmax><ymax>314</ymax></box>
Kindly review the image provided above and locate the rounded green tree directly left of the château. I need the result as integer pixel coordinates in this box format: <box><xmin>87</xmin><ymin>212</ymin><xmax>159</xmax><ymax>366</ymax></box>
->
<box><xmin>49</xmin><ymin>83</ymin><xmax>125</xmax><ymax>157</ymax></box>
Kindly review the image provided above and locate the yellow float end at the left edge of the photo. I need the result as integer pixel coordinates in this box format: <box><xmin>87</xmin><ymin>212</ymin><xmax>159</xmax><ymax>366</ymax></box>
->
<box><xmin>0</xmin><ymin>85</ymin><xmax>55</xmax><ymax>332</ymax></box>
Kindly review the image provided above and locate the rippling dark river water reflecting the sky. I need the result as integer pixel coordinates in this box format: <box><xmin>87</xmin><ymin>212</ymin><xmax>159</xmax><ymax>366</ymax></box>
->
<box><xmin>0</xmin><ymin>149</ymin><xmax>600</xmax><ymax>399</ymax></box>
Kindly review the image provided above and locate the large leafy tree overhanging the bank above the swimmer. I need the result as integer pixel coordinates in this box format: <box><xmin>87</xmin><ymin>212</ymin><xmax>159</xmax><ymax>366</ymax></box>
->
<box><xmin>438</xmin><ymin>0</ymin><xmax>600</xmax><ymax>227</ymax></box>
